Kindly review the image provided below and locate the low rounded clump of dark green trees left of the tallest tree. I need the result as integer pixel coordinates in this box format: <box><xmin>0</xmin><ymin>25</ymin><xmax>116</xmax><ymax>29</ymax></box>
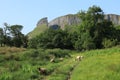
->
<box><xmin>28</xmin><ymin>28</ymin><xmax>72</xmax><ymax>49</ymax></box>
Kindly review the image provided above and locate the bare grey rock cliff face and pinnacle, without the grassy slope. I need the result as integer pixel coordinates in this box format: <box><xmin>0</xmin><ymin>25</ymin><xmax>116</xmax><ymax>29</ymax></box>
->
<box><xmin>37</xmin><ymin>14</ymin><xmax>120</xmax><ymax>29</ymax></box>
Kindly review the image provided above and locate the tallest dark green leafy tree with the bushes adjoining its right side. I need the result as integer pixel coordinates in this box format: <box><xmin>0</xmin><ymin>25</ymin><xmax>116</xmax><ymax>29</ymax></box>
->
<box><xmin>75</xmin><ymin>6</ymin><xmax>120</xmax><ymax>50</ymax></box>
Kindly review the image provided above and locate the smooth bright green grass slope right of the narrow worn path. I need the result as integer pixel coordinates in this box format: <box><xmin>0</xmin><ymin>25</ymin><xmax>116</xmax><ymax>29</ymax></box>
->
<box><xmin>71</xmin><ymin>47</ymin><xmax>120</xmax><ymax>80</ymax></box>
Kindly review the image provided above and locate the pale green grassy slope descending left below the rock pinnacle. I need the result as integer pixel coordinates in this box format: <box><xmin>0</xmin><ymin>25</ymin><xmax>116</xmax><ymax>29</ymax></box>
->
<box><xmin>28</xmin><ymin>24</ymin><xmax>48</xmax><ymax>38</ymax></box>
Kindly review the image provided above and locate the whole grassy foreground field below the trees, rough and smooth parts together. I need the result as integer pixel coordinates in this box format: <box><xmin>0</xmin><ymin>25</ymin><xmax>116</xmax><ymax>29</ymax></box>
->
<box><xmin>0</xmin><ymin>46</ymin><xmax>120</xmax><ymax>80</ymax></box>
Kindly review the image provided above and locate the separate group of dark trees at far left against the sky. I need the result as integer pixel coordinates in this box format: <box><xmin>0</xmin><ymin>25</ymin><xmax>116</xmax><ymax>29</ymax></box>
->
<box><xmin>0</xmin><ymin>23</ymin><xmax>28</xmax><ymax>47</ymax></box>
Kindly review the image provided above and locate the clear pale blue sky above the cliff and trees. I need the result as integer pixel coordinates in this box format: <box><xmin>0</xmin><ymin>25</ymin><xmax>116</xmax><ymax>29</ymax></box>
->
<box><xmin>0</xmin><ymin>0</ymin><xmax>120</xmax><ymax>34</ymax></box>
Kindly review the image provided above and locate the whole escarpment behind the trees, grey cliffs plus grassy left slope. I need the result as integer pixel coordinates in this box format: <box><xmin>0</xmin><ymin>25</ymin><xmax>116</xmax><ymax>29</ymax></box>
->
<box><xmin>28</xmin><ymin>14</ymin><xmax>120</xmax><ymax>37</ymax></box>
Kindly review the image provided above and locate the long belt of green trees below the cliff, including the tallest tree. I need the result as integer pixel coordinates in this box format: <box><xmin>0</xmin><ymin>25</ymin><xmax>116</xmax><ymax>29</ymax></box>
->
<box><xmin>28</xmin><ymin>5</ymin><xmax>120</xmax><ymax>51</ymax></box>
